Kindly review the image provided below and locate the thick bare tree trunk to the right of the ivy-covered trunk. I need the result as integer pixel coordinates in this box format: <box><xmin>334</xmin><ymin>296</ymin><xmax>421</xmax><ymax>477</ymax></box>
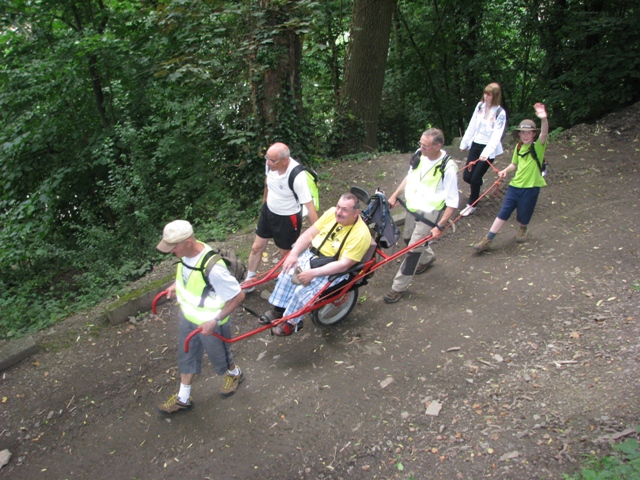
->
<box><xmin>341</xmin><ymin>0</ymin><xmax>396</xmax><ymax>153</ymax></box>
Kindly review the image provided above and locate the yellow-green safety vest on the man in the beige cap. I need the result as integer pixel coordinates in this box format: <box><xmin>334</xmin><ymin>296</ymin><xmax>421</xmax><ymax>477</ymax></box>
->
<box><xmin>176</xmin><ymin>242</ymin><xmax>229</xmax><ymax>325</ymax></box>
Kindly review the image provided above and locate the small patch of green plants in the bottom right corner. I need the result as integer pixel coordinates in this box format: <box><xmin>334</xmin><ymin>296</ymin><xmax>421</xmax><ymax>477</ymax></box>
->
<box><xmin>564</xmin><ymin>426</ymin><xmax>640</xmax><ymax>480</ymax></box>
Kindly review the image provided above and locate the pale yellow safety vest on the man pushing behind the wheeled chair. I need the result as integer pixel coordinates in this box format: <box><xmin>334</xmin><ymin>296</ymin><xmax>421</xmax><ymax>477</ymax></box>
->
<box><xmin>404</xmin><ymin>155</ymin><xmax>458</xmax><ymax>212</ymax></box>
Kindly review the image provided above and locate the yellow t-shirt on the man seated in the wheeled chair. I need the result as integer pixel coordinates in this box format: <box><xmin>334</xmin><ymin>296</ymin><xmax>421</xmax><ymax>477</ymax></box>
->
<box><xmin>311</xmin><ymin>207</ymin><xmax>371</xmax><ymax>262</ymax></box>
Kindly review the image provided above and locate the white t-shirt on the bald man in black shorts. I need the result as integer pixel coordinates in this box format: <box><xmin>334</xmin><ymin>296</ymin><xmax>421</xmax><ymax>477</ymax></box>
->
<box><xmin>265</xmin><ymin>158</ymin><xmax>313</xmax><ymax>215</ymax></box>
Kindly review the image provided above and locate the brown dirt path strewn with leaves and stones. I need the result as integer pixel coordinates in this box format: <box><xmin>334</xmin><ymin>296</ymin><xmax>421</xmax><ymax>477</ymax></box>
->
<box><xmin>0</xmin><ymin>104</ymin><xmax>640</xmax><ymax>480</ymax></box>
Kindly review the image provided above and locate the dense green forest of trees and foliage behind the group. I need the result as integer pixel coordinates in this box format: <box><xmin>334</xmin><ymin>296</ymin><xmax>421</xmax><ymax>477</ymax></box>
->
<box><xmin>0</xmin><ymin>0</ymin><xmax>640</xmax><ymax>338</ymax></box>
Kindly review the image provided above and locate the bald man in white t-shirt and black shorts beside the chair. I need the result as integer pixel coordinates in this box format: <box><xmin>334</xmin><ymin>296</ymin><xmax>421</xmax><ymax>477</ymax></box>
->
<box><xmin>245</xmin><ymin>143</ymin><xmax>318</xmax><ymax>286</ymax></box>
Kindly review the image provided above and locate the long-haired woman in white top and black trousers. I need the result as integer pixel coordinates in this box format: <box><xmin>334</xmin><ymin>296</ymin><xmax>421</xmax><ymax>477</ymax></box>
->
<box><xmin>460</xmin><ymin>83</ymin><xmax>507</xmax><ymax>217</ymax></box>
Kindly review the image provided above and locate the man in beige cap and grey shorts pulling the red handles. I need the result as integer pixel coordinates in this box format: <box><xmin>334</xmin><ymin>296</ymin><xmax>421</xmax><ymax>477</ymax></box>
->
<box><xmin>157</xmin><ymin>220</ymin><xmax>244</xmax><ymax>415</ymax></box>
